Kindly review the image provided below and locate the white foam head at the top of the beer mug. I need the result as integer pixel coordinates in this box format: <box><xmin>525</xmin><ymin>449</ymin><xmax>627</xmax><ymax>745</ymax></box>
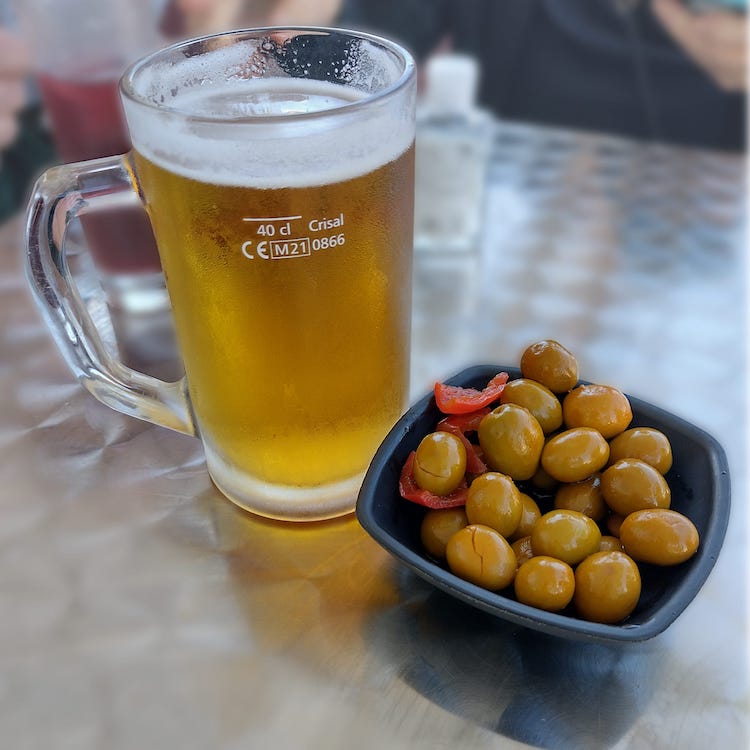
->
<box><xmin>123</xmin><ymin>34</ymin><xmax>416</xmax><ymax>187</ymax></box>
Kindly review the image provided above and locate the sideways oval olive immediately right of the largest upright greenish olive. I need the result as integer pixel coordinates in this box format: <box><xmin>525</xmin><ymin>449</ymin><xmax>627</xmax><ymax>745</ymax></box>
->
<box><xmin>542</xmin><ymin>427</ymin><xmax>609</xmax><ymax>482</ymax></box>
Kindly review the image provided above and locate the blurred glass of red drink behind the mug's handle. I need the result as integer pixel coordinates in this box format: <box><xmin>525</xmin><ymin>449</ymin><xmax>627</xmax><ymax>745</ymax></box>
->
<box><xmin>16</xmin><ymin>0</ymin><xmax>168</xmax><ymax>312</ymax></box>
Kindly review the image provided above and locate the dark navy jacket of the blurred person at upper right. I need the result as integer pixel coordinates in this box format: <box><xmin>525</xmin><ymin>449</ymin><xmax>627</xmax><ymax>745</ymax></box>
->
<box><xmin>341</xmin><ymin>0</ymin><xmax>745</xmax><ymax>150</ymax></box>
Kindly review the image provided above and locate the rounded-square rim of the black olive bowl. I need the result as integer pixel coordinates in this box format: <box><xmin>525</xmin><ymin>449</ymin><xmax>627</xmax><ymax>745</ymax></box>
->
<box><xmin>356</xmin><ymin>364</ymin><xmax>731</xmax><ymax>643</ymax></box>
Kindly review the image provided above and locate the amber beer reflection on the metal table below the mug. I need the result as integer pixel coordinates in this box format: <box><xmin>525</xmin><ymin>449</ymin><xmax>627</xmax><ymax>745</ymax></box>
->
<box><xmin>200</xmin><ymin>490</ymin><xmax>406</xmax><ymax>664</ymax></box>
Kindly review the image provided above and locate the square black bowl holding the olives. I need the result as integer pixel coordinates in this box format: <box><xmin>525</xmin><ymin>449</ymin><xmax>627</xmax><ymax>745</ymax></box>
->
<box><xmin>357</xmin><ymin>365</ymin><xmax>730</xmax><ymax>642</ymax></box>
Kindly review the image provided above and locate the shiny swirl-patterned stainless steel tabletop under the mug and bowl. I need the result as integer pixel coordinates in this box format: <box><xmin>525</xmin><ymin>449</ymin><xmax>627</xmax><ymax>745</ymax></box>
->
<box><xmin>0</xmin><ymin>120</ymin><xmax>750</xmax><ymax>750</ymax></box>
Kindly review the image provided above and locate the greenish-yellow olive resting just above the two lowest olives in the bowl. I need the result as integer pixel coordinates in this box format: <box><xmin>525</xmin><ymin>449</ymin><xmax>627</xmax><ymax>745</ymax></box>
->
<box><xmin>531</xmin><ymin>510</ymin><xmax>602</xmax><ymax>565</ymax></box>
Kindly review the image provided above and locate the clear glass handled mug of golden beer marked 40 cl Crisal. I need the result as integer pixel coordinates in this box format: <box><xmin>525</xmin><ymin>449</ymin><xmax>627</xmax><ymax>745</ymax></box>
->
<box><xmin>26</xmin><ymin>28</ymin><xmax>416</xmax><ymax>520</ymax></box>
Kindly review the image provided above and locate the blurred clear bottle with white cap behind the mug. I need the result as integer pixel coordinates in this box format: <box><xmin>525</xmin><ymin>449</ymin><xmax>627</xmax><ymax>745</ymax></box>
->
<box><xmin>414</xmin><ymin>53</ymin><xmax>493</xmax><ymax>253</ymax></box>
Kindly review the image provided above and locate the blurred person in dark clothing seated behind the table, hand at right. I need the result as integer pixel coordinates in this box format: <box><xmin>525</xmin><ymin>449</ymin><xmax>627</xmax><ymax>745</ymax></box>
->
<box><xmin>184</xmin><ymin>0</ymin><xmax>747</xmax><ymax>151</ymax></box>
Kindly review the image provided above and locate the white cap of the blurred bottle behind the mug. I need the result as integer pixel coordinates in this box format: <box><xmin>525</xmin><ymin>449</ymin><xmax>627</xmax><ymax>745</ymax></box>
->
<box><xmin>424</xmin><ymin>52</ymin><xmax>479</xmax><ymax>113</ymax></box>
